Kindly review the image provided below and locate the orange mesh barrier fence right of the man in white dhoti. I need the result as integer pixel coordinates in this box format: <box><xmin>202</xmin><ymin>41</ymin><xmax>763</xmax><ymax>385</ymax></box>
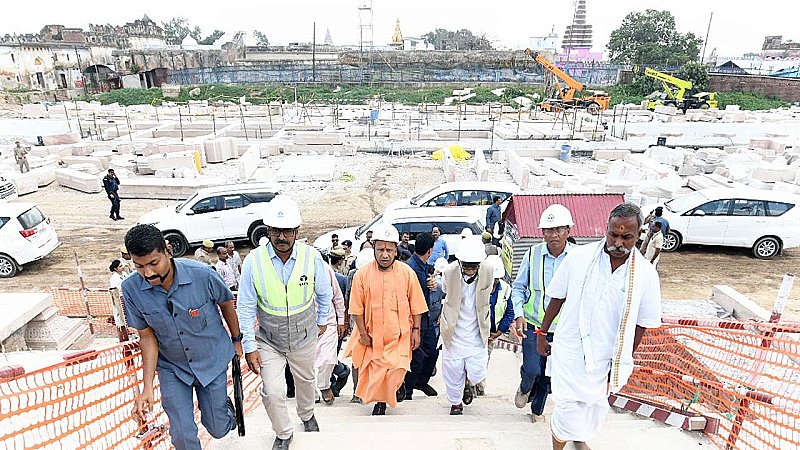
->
<box><xmin>623</xmin><ymin>318</ymin><xmax>800</xmax><ymax>450</ymax></box>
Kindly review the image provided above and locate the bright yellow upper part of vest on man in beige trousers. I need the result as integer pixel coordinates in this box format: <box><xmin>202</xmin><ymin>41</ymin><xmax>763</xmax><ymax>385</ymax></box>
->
<box><xmin>253</xmin><ymin>242</ymin><xmax>314</xmax><ymax>317</ymax></box>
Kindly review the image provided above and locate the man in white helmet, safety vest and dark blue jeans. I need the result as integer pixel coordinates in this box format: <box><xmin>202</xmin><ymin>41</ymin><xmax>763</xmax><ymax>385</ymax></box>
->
<box><xmin>511</xmin><ymin>203</ymin><xmax>574</xmax><ymax>422</ymax></box>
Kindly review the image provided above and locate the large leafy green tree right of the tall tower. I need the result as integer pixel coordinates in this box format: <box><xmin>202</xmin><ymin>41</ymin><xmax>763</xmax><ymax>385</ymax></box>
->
<box><xmin>607</xmin><ymin>9</ymin><xmax>703</xmax><ymax>66</ymax></box>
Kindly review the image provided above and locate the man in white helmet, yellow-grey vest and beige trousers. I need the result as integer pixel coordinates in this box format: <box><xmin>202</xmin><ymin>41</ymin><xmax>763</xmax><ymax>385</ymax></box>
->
<box><xmin>237</xmin><ymin>195</ymin><xmax>333</xmax><ymax>450</ymax></box>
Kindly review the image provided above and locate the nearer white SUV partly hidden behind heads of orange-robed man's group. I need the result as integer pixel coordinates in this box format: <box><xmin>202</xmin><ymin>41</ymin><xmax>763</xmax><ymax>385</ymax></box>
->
<box><xmin>314</xmin><ymin>208</ymin><xmax>484</xmax><ymax>255</ymax></box>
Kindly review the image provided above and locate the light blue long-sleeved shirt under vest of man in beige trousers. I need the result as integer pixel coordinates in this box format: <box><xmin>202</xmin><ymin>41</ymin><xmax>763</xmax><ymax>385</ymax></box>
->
<box><xmin>236</xmin><ymin>244</ymin><xmax>333</xmax><ymax>353</ymax></box>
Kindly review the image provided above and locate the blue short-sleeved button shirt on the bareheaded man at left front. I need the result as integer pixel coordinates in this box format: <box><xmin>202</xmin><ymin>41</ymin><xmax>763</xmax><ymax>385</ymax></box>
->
<box><xmin>122</xmin><ymin>258</ymin><xmax>233</xmax><ymax>386</ymax></box>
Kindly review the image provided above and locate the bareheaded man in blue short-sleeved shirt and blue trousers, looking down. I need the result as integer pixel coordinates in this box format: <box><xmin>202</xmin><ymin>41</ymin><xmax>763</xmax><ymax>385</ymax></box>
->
<box><xmin>122</xmin><ymin>225</ymin><xmax>242</xmax><ymax>450</ymax></box>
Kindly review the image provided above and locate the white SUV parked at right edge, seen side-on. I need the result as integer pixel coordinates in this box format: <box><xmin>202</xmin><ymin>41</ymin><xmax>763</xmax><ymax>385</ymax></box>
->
<box><xmin>642</xmin><ymin>188</ymin><xmax>800</xmax><ymax>259</ymax></box>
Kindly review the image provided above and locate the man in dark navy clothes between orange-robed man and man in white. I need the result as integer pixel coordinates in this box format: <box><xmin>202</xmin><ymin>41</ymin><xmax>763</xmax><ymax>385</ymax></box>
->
<box><xmin>405</xmin><ymin>233</ymin><xmax>441</xmax><ymax>400</ymax></box>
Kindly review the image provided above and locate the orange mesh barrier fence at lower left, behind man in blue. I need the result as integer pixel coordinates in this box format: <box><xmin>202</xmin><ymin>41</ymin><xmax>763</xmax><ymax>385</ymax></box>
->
<box><xmin>0</xmin><ymin>342</ymin><xmax>261</xmax><ymax>450</ymax></box>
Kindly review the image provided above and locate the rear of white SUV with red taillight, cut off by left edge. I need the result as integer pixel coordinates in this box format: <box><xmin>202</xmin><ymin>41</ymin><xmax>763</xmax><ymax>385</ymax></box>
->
<box><xmin>0</xmin><ymin>201</ymin><xmax>61</xmax><ymax>278</ymax></box>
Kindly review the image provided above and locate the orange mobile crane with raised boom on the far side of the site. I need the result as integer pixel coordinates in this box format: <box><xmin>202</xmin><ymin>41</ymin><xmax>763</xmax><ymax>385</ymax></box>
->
<box><xmin>525</xmin><ymin>49</ymin><xmax>611</xmax><ymax>114</ymax></box>
